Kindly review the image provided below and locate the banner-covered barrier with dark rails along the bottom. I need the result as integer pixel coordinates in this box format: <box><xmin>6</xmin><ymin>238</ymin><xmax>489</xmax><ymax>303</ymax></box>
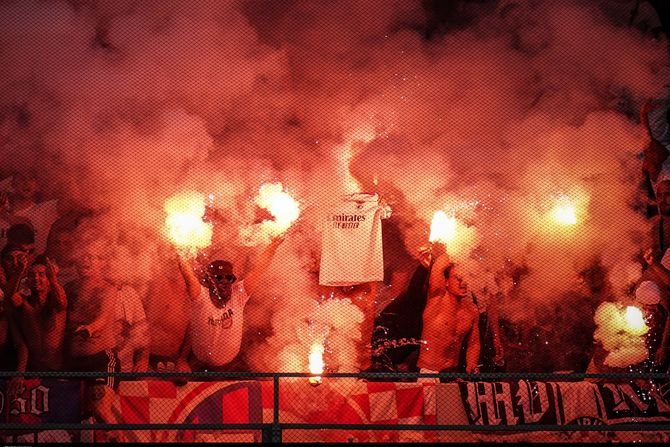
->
<box><xmin>0</xmin><ymin>372</ymin><xmax>670</xmax><ymax>443</ymax></box>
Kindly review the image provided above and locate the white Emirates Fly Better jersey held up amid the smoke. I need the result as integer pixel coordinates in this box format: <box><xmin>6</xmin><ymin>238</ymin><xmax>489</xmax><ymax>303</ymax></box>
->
<box><xmin>319</xmin><ymin>193</ymin><xmax>391</xmax><ymax>286</ymax></box>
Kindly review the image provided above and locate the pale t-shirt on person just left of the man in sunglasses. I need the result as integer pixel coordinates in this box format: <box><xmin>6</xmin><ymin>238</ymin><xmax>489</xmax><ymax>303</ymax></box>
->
<box><xmin>116</xmin><ymin>285</ymin><xmax>149</xmax><ymax>372</ymax></box>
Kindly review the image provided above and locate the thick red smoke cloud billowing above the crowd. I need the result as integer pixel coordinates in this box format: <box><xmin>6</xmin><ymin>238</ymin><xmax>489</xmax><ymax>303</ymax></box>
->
<box><xmin>0</xmin><ymin>0</ymin><xmax>667</xmax><ymax>369</ymax></box>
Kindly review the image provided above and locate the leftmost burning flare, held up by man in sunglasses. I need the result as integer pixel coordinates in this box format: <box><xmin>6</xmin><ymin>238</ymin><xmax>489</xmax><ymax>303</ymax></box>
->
<box><xmin>164</xmin><ymin>191</ymin><xmax>212</xmax><ymax>251</ymax></box>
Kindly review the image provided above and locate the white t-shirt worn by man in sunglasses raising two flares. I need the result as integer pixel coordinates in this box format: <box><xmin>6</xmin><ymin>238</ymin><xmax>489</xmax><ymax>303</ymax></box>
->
<box><xmin>189</xmin><ymin>281</ymin><xmax>249</xmax><ymax>366</ymax></box>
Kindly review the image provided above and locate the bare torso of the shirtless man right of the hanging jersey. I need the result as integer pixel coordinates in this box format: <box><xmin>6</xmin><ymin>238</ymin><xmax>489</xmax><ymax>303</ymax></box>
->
<box><xmin>417</xmin><ymin>295</ymin><xmax>479</xmax><ymax>371</ymax></box>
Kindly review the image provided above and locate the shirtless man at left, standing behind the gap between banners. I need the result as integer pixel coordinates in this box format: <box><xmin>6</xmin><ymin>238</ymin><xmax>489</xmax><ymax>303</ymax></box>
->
<box><xmin>65</xmin><ymin>240</ymin><xmax>120</xmax><ymax>423</ymax></box>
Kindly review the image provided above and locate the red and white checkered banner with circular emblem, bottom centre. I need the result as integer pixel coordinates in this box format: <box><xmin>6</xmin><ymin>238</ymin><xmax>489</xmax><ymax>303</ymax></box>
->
<box><xmin>115</xmin><ymin>379</ymin><xmax>436</xmax><ymax>442</ymax></box>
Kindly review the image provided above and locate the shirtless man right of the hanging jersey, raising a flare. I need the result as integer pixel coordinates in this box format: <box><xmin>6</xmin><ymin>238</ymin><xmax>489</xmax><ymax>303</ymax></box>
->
<box><xmin>417</xmin><ymin>254</ymin><xmax>480</xmax><ymax>382</ymax></box>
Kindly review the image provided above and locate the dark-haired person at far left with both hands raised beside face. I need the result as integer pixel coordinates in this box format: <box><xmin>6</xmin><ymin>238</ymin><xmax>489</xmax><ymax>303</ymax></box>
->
<box><xmin>12</xmin><ymin>255</ymin><xmax>67</xmax><ymax>371</ymax></box>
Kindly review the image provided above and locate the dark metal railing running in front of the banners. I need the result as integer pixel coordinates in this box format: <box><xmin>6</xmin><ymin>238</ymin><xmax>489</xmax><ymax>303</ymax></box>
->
<box><xmin>0</xmin><ymin>372</ymin><xmax>670</xmax><ymax>443</ymax></box>
